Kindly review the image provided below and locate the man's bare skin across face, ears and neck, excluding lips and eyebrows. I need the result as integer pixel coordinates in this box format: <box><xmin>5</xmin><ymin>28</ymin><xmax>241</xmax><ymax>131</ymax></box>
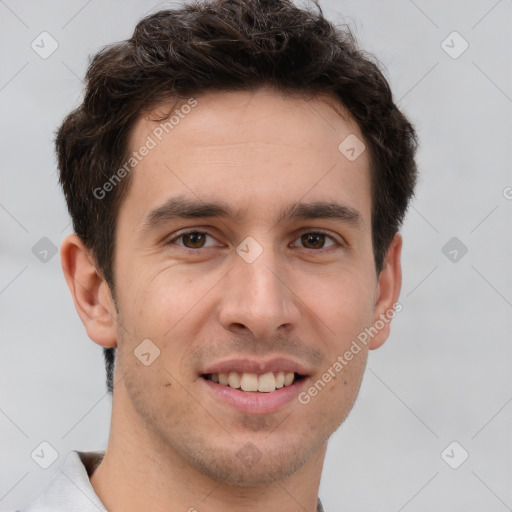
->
<box><xmin>61</xmin><ymin>89</ymin><xmax>401</xmax><ymax>512</ymax></box>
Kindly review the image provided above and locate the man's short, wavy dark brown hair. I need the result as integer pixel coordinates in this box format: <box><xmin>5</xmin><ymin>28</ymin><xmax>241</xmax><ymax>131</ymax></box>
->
<box><xmin>56</xmin><ymin>0</ymin><xmax>417</xmax><ymax>391</ymax></box>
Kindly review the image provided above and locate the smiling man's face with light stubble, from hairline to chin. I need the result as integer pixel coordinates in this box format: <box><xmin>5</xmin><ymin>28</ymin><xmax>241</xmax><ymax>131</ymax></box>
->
<box><xmin>114</xmin><ymin>90</ymin><xmax>378</xmax><ymax>485</ymax></box>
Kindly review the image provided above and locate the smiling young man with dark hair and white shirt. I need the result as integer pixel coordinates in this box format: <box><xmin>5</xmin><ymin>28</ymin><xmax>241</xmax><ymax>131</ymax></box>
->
<box><xmin>17</xmin><ymin>0</ymin><xmax>416</xmax><ymax>512</ymax></box>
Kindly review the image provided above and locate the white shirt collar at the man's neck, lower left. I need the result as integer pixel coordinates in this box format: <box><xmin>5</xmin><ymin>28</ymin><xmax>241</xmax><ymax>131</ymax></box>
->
<box><xmin>16</xmin><ymin>451</ymin><xmax>324</xmax><ymax>512</ymax></box>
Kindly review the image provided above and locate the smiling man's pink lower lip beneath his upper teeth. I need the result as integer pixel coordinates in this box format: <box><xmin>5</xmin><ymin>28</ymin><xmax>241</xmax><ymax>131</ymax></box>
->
<box><xmin>200</xmin><ymin>377</ymin><xmax>307</xmax><ymax>414</ymax></box>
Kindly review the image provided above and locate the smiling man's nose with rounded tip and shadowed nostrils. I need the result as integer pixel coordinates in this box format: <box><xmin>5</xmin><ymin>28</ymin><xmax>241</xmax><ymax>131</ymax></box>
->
<box><xmin>220</xmin><ymin>244</ymin><xmax>300</xmax><ymax>339</ymax></box>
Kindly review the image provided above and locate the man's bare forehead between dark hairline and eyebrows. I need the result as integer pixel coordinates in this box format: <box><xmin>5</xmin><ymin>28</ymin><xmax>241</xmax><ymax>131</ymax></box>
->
<box><xmin>121</xmin><ymin>89</ymin><xmax>370</xmax><ymax>228</ymax></box>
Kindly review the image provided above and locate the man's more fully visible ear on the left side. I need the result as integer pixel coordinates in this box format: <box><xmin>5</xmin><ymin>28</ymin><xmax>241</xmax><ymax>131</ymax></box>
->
<box><xmin>60</xmin><ymin>234</ymin><xmax>117</xmax><ymax>347</ymax></box>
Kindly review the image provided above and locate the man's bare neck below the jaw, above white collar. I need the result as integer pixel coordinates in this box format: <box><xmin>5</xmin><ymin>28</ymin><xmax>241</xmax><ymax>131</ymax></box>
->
<box><xmin>90</xmin><ymin>390</ymin><xmax>327</xmax><ymax>512</ymax></box>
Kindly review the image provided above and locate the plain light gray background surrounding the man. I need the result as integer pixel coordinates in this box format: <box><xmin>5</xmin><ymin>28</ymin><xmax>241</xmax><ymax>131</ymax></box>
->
<box><xmin>0</xmin><ymin>0</ymin><xmax>512</xmax><ymax>512</ymax></box>
